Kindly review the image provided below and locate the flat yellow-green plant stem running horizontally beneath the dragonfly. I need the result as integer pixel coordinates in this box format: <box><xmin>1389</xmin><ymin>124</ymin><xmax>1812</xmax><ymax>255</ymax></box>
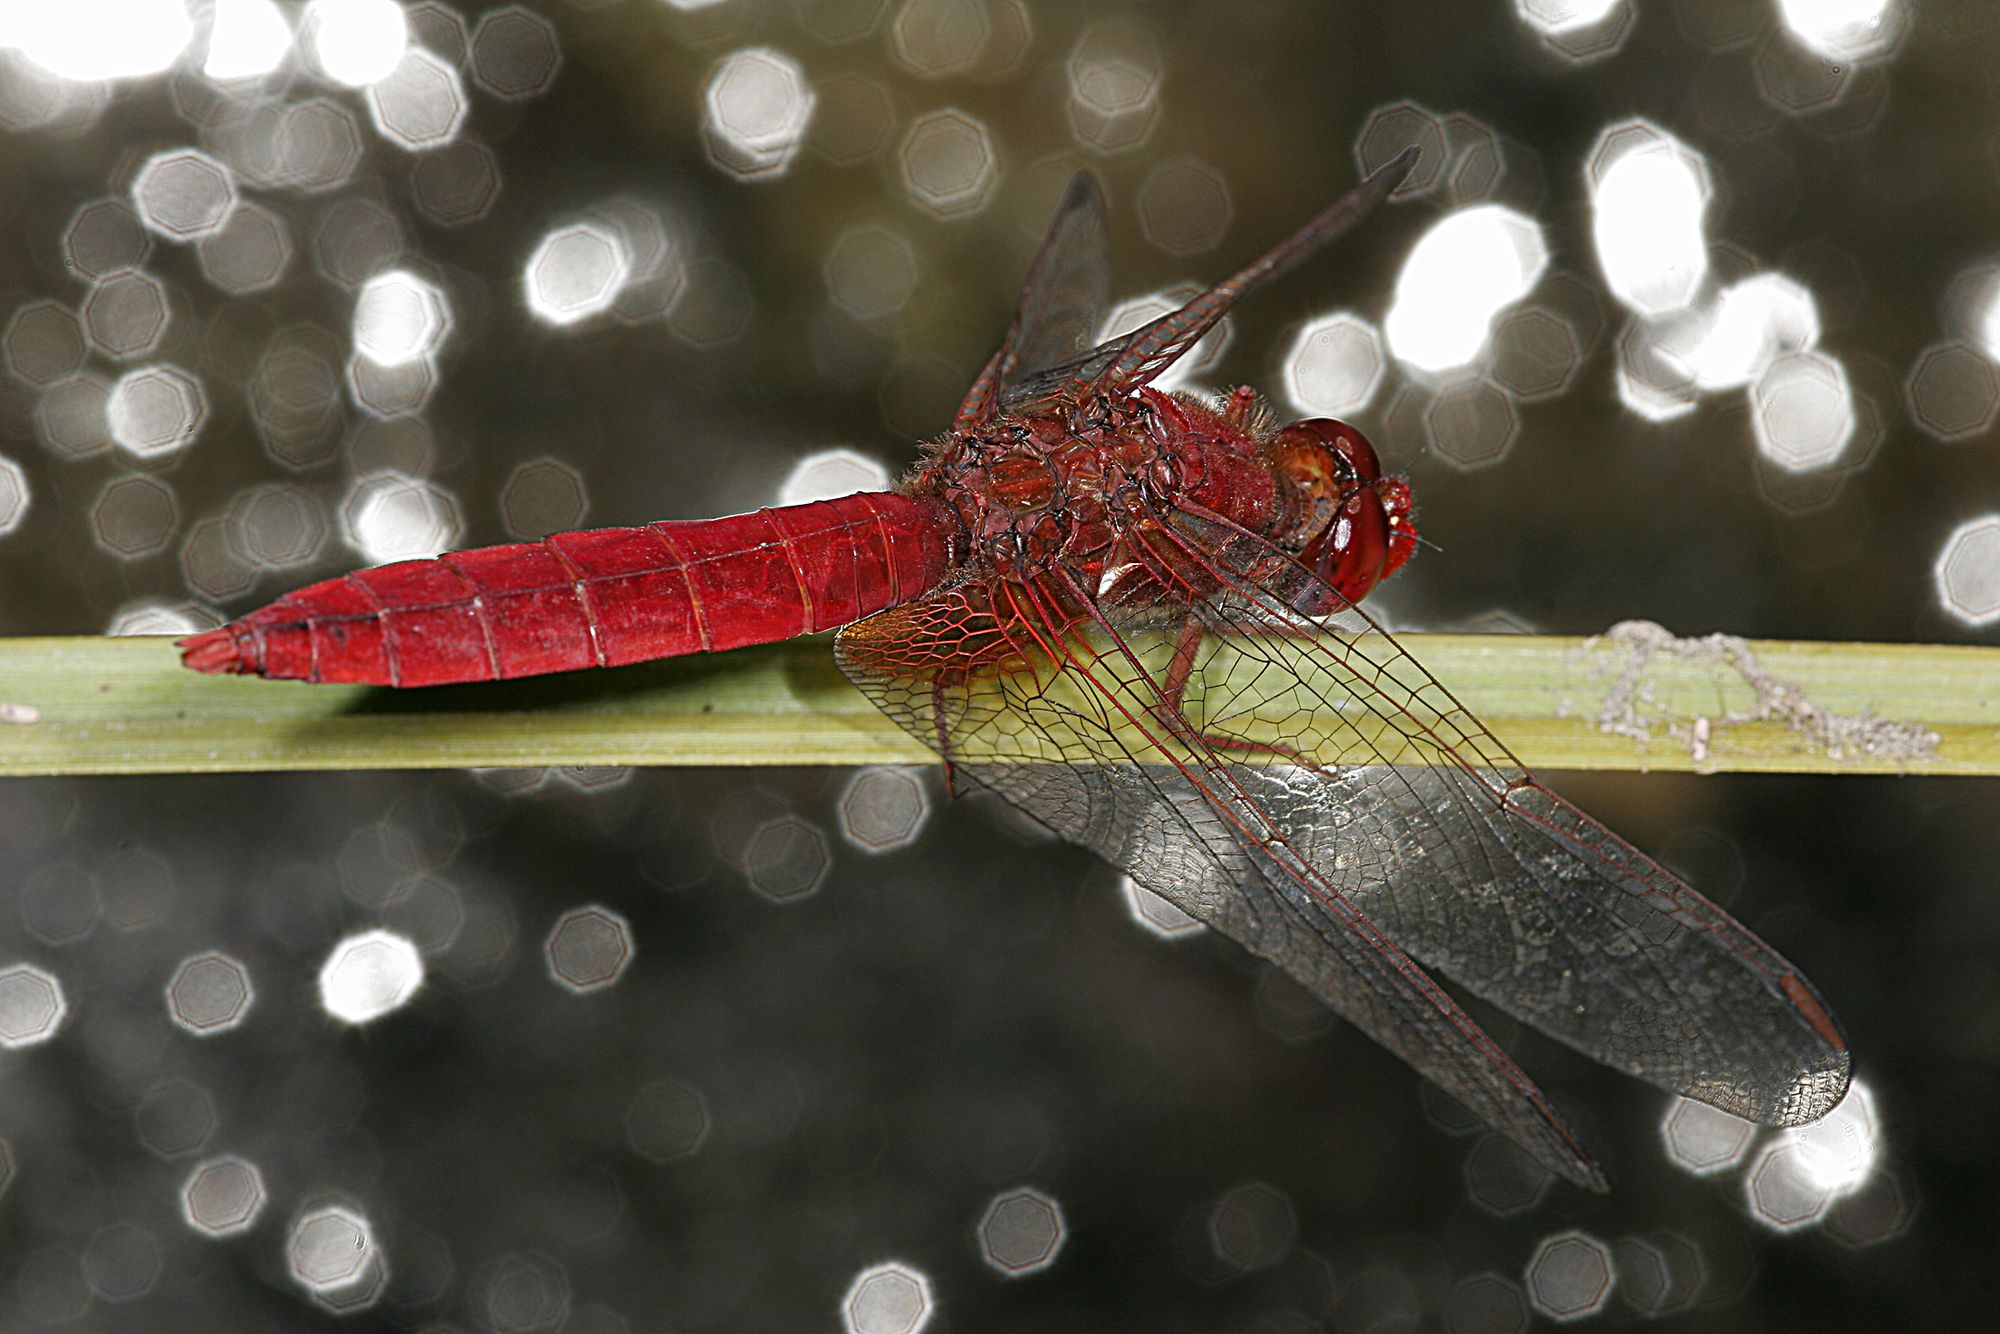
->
<box><xmin>0</xmin><ymin>634</ymin><xmax>2000</xmax><ymax>774</ymax></box>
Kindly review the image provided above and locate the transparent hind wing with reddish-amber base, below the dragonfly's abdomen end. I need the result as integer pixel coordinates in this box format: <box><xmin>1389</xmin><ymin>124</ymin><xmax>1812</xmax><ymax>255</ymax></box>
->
<box><xmin>838</xmin><ymin>584</ymin><xmax>1604</xmax><ymax>1190</ymax></box>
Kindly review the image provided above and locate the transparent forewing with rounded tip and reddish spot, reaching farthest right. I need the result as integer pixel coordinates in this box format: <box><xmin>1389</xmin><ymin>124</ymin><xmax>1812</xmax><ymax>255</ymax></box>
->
<box><xmin>1144</xmin><ymin>508</ymin><xmax>1850</xmax><ymax>1126</ymax></box>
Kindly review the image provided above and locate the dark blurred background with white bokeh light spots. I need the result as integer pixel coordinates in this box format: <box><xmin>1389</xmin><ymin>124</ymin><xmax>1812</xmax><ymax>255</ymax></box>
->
<box><xmin>0</xmin><ymin>0</ymin><xmax>2000</xmax><ymax>1334</ymax></box>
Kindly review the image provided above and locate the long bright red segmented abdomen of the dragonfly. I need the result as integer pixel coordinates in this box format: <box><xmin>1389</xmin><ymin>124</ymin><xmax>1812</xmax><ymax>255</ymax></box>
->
<box><xmin>180</xmin><ymin>492</ymin><xmax>958</xmax><ymax>686</ymax></box>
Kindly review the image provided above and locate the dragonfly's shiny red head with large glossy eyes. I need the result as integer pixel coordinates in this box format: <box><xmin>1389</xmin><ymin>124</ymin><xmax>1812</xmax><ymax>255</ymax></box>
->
<box><xmin>1270</xmin><ymin>416</ymin><xmax>1416</xmax><ymax>616</ymax></box>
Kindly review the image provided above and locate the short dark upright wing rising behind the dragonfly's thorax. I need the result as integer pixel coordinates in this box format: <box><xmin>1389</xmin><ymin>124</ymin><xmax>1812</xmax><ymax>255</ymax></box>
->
<box><xmin>956</xmin><ymin>172</ymin><xmax>1110</xmax><ymax>430</ymax></box>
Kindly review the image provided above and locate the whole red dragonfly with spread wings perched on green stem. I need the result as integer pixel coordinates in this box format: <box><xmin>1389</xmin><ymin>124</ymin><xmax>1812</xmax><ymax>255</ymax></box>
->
<box><xmin>182</xmin><ymin>150</ymin><xmax>1848</xmax><ymax>1190</ymax></box>
